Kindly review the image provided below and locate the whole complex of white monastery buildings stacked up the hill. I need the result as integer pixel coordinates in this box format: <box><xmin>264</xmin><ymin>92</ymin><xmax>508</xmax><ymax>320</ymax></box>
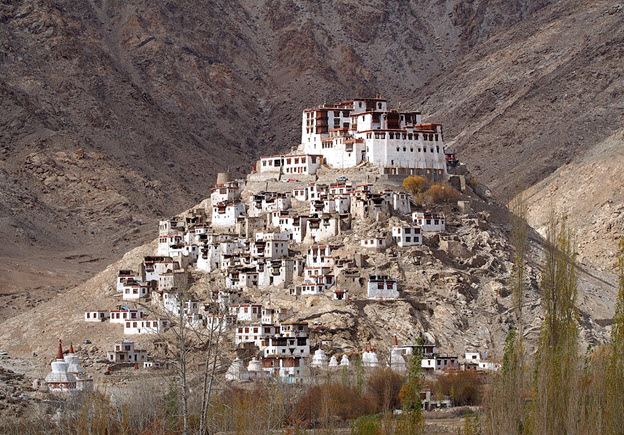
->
<box><xmin>49</xmin><ymin>97</ymin><xmax>497</xmax><ymax>396</ymax></box>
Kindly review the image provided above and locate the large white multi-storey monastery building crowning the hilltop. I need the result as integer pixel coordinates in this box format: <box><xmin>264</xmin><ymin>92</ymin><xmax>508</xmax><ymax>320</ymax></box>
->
<box><xmin>301</xmin><ymin>97</ymin><xmax>446</xmax><ymax>175</ymax></box>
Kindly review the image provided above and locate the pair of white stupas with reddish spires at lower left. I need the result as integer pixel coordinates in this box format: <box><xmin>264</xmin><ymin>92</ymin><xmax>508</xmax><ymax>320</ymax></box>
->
<box><xmin>45</xmin><ymin>340</ymin><xmax>93</xmax><ymax>393</ymax></box>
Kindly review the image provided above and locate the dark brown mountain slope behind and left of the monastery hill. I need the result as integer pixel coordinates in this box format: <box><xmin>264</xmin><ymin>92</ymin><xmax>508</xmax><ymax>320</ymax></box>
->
<box><xmin>0</xmin><ymin>0</ymin><xmax>546</xmax><ymax>289</ymax></box>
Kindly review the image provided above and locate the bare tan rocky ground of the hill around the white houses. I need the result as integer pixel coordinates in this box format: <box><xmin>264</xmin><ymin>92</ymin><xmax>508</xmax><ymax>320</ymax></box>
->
<box><xmin>0</xmin><ymin>168</ymin><xmax>615</xmax><ymax>384</ymax></box>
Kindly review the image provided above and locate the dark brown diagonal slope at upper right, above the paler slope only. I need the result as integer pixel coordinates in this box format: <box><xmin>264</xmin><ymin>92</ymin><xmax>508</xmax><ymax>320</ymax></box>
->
<box><xmin>412</xmin><ymin>0</ymin><xmax>624</xmax><ymax>199</ymax></box>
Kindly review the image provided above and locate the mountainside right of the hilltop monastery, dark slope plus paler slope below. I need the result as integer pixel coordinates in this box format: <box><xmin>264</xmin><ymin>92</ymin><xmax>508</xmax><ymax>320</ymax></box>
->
<box><xmin>412</xmin><ymin>1</ymin><xmax>624</xmax><ymax>274</ymax></box>
